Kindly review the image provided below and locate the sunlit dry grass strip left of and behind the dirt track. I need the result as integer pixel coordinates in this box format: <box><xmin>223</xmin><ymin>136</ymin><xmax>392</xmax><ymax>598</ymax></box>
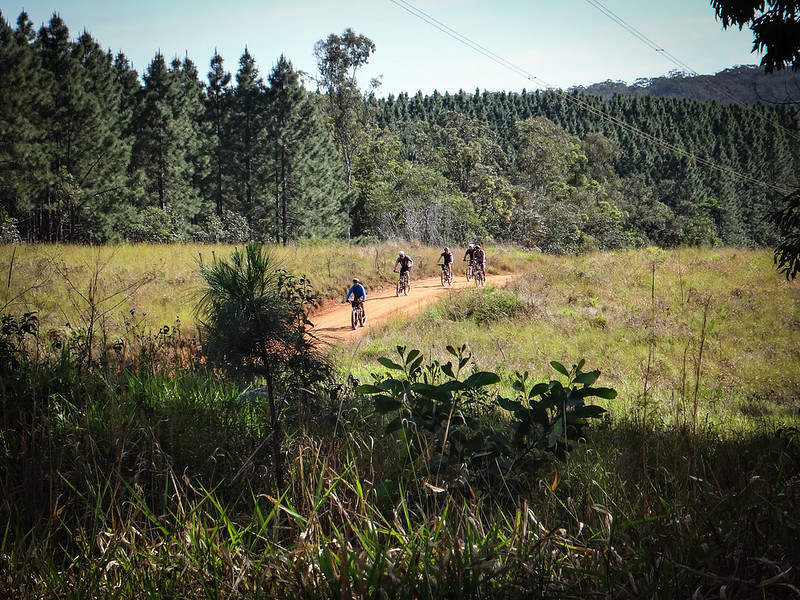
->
<box><xmin>0</xmin><ymin>244</ymin><xmax>525</xmax><ymax>336</ymax></box>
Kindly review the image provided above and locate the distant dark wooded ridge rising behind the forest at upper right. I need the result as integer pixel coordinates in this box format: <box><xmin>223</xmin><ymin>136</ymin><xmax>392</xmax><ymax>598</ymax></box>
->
<box><xmin>571</xmin><ymin>65</ymin><xmax>800</xmax><ymax>105</ymax></box>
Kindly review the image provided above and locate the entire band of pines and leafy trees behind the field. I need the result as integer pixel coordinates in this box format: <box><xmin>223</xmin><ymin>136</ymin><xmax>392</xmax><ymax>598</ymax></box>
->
<box><xmin>0</xmin><ymin>13</ymin><xmax>800</xmax><ymax>253</ymax></box>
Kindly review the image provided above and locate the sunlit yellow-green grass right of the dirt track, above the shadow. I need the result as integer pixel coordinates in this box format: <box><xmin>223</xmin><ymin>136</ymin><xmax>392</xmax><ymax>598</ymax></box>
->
<box><xmin>348</xmin><ymin>249</ymin><xmax>800</xmax><ymax>422</ymax></box>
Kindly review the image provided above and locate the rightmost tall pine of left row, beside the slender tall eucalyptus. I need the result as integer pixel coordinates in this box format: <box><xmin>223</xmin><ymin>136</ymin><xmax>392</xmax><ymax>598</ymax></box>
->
<box><xmin>266</xmin><ymin>55</ymin><xmax>348</xmax><ymax>244</ymax></box>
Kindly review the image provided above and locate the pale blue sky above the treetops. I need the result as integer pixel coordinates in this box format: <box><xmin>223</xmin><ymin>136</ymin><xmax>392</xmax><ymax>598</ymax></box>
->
<box><xmin>0</xmin><ymin>0</ymin><xmax>760</xmax><ymax>96</ymax></box>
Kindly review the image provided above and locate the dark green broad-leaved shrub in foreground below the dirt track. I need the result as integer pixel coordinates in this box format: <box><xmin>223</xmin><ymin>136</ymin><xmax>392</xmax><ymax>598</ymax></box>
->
<box><xmin>356</xmin><ymin>346</ymin><xmax>617</xmax><ymax>492</ymax></box>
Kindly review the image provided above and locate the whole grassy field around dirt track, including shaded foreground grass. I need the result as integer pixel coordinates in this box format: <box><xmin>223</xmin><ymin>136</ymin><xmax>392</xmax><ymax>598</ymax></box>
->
<box><xmin>0</xmin><ymin>241</ymin><xmax>800</xmax><ymax>598</ymax></box>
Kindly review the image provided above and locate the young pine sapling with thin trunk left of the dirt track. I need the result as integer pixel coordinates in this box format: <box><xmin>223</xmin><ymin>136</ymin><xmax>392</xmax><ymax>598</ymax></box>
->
<box><xmin>197</xmin><ymin>244</ymin><xmax>327</xmax><ymax>491</ymax></box>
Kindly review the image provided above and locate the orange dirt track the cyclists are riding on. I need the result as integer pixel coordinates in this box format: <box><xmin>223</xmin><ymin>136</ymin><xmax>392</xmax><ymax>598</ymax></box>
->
<box><xmin>310</xmin><ymin>274</ymin><xmax>513</xmax><ymax>345</ymax></box>
